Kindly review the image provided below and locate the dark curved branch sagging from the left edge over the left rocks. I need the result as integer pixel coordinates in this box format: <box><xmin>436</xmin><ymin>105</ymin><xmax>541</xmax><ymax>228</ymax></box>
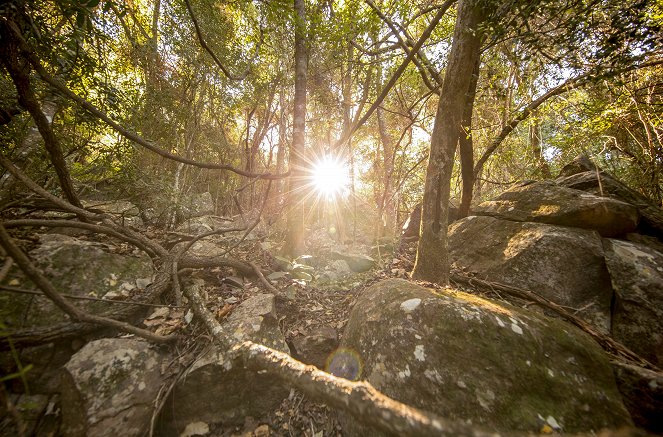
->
<box><xmin>0</xmin><ymin>222</ymin><xmax>177</xmax><ymax>343</ymax></box>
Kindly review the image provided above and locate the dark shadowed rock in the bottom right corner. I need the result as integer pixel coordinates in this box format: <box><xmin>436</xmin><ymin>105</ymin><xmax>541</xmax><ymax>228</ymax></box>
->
<box><xmin>613</xmin><ymin>361</ymin><xmax>663</xmax><ymax>434</ymax></box>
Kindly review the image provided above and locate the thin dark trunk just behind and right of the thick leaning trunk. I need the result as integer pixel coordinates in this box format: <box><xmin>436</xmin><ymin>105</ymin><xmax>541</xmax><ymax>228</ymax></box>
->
<box><xmin>458</xmin><ymin>56</ymin><xmax>481</xmax><ymax>218</ymax></box>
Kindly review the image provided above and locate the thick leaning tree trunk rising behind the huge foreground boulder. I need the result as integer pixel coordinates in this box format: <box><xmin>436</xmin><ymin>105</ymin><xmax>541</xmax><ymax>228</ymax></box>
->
<box><xmin>412</xmin><ymin>0</ymin><xmax>483</xmax><ymax>284</ymax></box>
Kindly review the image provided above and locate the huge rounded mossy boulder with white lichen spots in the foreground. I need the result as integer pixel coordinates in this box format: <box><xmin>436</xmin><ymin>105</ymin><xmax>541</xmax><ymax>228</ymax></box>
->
<box><xmin>342</xmin><ymin>279</ymin><xmax>631</xmax><ymax>436</ymax></box>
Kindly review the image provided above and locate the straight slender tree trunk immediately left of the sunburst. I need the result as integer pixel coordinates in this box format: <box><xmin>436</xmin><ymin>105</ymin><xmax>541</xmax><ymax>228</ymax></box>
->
<box><xmin>285</xmin><ymin>0</ymin><xmax>308</xmax><ymax>257</ymax></box>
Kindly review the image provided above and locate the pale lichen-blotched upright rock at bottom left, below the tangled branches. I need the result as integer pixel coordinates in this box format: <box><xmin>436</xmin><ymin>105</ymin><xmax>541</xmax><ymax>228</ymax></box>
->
<box><xmin>61</xmin><ymin>338</ymin><xmax>165</xmax><ymax>436</ymax></box>
